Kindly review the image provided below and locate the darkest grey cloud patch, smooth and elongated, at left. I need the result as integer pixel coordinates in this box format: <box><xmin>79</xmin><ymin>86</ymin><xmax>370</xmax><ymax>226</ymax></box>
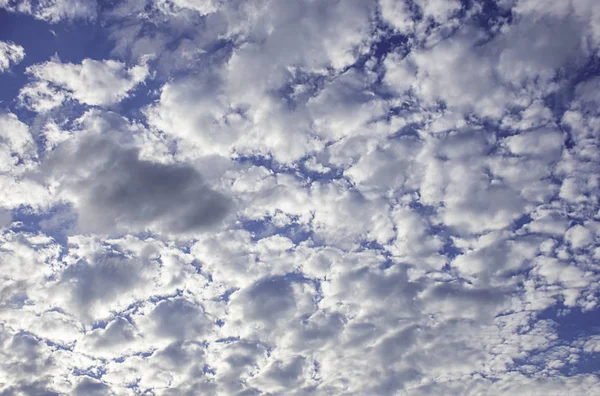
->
<box><xmin>51</xmin><ymin>136</ymin><xmax>231</xmax><ymax>233</ymax></box>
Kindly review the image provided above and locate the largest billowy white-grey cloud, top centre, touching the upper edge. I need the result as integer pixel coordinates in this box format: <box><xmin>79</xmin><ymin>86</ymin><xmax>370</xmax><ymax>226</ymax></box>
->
<box><xmin>139</xmin><ymin>1</ymin><xmax>377</xmax><ymax>162</ymax></box>
